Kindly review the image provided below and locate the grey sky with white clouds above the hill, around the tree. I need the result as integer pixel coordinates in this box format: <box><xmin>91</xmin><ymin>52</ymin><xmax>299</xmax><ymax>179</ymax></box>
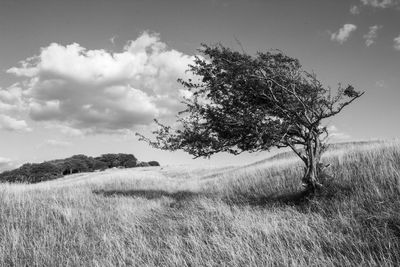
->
<box><xmin>0</xmin><ymin>0</ymin><xmax>400</xmax><ymax>170</ymax></box>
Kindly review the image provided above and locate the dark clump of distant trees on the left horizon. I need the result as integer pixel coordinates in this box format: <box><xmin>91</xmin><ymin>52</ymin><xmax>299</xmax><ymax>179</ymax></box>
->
<box><xmin>0</xmin><ymin>153</ymin><xmax>160</xmax><ymax>183</ymax></box>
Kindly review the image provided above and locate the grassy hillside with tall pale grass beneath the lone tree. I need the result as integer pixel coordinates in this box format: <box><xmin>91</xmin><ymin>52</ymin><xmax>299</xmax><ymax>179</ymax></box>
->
<box><xmin>0</xmin><ymin>142</ymin><xmax>400</xmax><ymax>266</ymax></box>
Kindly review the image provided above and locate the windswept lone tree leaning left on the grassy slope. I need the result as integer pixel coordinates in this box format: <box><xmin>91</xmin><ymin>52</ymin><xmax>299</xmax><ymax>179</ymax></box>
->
<box><xmin>138</xmin><ymin>45</ymin><xmax>363</xmax><ymax>193</ymax></box>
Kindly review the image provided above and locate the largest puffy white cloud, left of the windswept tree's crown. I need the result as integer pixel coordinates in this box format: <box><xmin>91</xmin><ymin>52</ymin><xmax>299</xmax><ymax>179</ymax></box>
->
<box><xmin>7</xmin><ymin>32</ymin><xmax>194</xmax><ymax>133</ymax></box>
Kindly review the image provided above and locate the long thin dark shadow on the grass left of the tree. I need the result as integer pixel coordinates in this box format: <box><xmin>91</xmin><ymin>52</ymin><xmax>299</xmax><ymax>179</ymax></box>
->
<box><xmin>92</xmin><ymin>190</ymin><xmax>200</xmax><ymax>201</ymax></box>
